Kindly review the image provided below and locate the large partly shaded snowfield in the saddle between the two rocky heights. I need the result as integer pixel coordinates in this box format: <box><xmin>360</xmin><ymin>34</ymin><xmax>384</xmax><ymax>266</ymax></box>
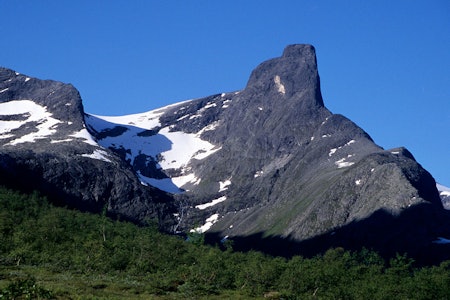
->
<box><xmin>85</xmin><ymin>100</ymin><xmax>220</xmax><ymax>193</ymax></box>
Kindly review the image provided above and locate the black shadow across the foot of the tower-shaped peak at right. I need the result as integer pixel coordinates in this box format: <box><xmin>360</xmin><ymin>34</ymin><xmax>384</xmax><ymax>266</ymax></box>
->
<box><xmin>206</xmin><ymin>204</ymin><xmax>450</xmax><ymax>266</ymax></box>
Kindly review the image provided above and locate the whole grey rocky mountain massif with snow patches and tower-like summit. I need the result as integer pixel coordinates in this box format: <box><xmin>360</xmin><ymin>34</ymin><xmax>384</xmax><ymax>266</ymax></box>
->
<box><xmin>0</xmin><ymin>45</ymin><xmax>450</xmax><ymax>258</ymax></box>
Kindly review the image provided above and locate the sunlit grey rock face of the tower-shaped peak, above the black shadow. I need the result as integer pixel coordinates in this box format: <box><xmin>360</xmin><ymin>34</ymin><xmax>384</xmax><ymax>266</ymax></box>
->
<box><xmin>178</xmin><ymin>45</ymin><xmax>442</xmax><ymax>244</ymax></box>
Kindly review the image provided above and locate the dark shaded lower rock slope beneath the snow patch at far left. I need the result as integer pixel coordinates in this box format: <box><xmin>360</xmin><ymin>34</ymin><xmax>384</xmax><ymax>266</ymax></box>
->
<box><xmin>0</xmin><ymin>150</ymin><xmax>175</xmax><ymax>229</ymax></box>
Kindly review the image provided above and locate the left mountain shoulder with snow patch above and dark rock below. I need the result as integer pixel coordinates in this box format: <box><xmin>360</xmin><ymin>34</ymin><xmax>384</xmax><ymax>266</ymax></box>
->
<box><xmin>0</xmin><ymin>68</ymin><xmax>176</xmax><ymax>224</ymax></box>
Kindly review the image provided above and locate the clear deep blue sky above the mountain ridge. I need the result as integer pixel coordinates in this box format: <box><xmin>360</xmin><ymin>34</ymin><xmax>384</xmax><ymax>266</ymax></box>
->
<box><xmin>0</xmin><ymin>0</ymin><xmax>450</xmax><ymax>186</ymax></box>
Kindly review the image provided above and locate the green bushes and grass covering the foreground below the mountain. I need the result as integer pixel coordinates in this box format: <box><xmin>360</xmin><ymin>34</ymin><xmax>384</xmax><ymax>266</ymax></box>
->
<box><xmin>0</xmin><ymin>188</ymin><xmax>450</xmax><ymax>299</ymax></box>
